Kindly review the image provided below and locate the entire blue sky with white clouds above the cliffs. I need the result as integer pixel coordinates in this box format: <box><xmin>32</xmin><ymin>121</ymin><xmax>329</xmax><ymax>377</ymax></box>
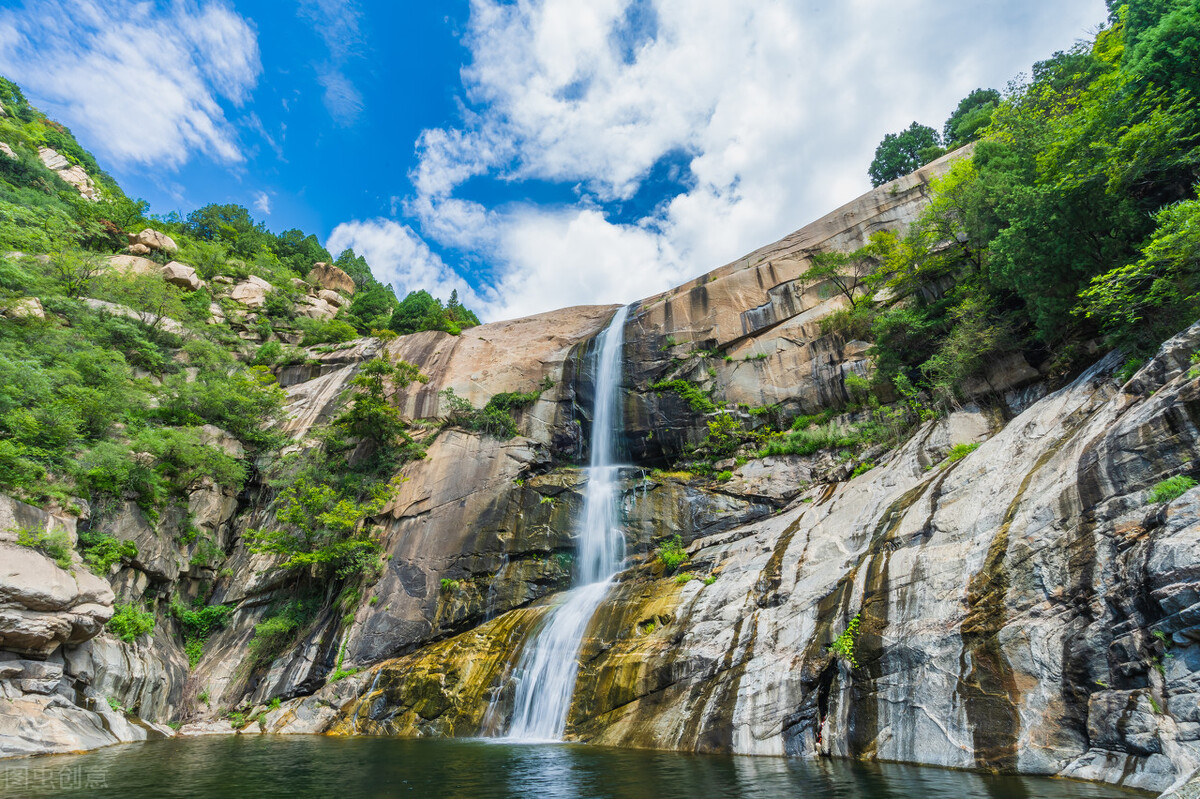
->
<box><xmin>0</xmin><ymin>0</ymin><xmax>1105</xmax><ymax>319</ymax></box>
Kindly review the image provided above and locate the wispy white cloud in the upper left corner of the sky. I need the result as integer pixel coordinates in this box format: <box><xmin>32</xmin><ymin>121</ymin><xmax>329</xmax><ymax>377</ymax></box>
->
<box><xmin>0</xmin><ymin>0</ymin><xmax>262</xmax><ymax>167</ymax></box>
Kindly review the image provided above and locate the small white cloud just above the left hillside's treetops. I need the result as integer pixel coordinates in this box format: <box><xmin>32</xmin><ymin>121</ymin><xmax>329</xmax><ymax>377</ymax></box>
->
<box><xmin>325</xmin><ymin>220</ymin><xmax>485</xmax><ymax>308</ymax></box>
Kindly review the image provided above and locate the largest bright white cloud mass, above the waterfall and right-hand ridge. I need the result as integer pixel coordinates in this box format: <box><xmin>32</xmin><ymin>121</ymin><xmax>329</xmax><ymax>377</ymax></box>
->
<box><xmin>386</xmin><ymin>0</ymin><xmax>1105</xmax><ymax>318</ymax></box>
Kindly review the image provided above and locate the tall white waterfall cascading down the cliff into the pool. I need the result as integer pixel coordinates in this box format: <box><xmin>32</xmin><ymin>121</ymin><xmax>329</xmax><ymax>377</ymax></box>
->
<box><xmin>508</xmin><ymin>302</ymin><xmax>629</xmax><ymax>740</ymax></box>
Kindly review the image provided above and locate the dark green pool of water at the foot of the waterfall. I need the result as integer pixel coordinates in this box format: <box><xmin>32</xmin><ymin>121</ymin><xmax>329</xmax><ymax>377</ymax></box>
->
<box><xmin>0</xmin><ymin>735</ymin><xmax>1147</xmax><ymax>799</ymax></box>
